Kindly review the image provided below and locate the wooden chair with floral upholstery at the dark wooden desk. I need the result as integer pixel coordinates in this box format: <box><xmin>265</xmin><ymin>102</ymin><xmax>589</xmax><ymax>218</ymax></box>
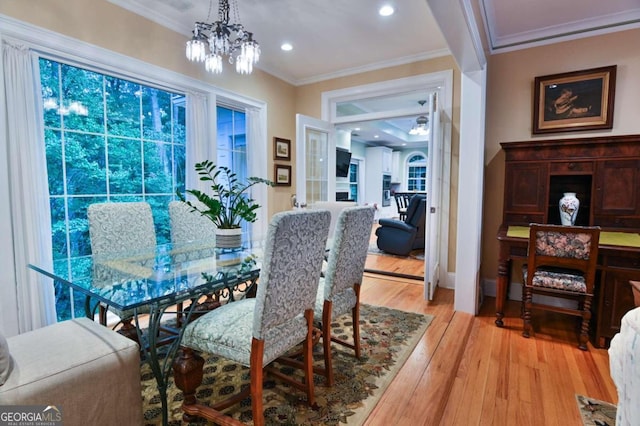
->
<box><xmin>522</xmin><ymin>224</ymin><xmax>600</xmax><ymax>350</ymax></box>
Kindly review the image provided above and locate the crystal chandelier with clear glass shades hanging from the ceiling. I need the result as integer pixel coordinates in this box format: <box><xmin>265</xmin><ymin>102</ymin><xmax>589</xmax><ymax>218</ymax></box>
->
<box><xmin>187</xmin><ymin>0</ymin><xmax>260</xmax><ymax>74</ymax></box>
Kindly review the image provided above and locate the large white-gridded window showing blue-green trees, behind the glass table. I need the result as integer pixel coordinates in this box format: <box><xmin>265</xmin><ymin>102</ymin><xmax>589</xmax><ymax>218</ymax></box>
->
<box><xmin>40</xmin><ymin>59</ymin><xmax>185</xmax><ymax>320</ymax></box>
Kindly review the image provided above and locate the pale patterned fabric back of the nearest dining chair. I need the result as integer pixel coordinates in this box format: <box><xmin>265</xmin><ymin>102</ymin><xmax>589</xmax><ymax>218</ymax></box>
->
<box><xmin>253</xmin><ymin>210</ymin><xmax>331</xmax><ymax>339</ymax></box>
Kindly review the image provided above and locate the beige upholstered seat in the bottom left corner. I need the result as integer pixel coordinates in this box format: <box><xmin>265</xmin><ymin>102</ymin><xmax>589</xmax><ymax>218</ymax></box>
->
<box><xmin>0</xmin><ymin>318</ymin><xmax>143</xmax><ymax>426</ymax></box>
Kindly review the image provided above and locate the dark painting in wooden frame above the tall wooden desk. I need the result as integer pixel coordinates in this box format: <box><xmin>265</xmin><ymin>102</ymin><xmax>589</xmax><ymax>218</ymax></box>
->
<box><xmin>533</xmin><ymin>65</ymin><xmax>616</xmax><ymax>134</ymax></box>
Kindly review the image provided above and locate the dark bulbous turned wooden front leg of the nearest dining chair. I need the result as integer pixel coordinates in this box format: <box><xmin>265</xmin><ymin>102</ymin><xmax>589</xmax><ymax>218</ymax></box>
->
<box><xmin>173</xmin><ymin>347</ymin><xmax>204</xmax><ymax>422</ymax></box>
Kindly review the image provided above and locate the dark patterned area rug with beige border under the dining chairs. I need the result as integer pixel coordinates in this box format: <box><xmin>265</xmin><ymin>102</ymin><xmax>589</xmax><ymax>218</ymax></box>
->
<box><xmin>142</xmin><ymin>304</ymin><xmax>433</xmax><ymax>426</ymax></box>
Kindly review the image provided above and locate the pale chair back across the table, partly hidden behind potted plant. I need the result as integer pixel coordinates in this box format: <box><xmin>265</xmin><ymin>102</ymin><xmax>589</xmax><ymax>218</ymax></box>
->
<box><xmin>169</xmin><ymin>201</ymin><xmax>216</xmax><ymax>244</ymax></box>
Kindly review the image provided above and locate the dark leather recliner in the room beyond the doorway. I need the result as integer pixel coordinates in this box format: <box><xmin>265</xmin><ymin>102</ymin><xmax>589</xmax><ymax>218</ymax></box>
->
<box><xmin>376</xmin><ymin>194</ymin><xmax>427</xmax><ymax>256</ymax></box>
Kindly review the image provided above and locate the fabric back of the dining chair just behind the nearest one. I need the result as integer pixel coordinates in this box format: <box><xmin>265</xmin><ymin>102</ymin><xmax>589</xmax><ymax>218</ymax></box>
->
<box><xmin>324</xmin><ymin>206</ymin><xmax>374</xmax><ymax>307</ymax></box>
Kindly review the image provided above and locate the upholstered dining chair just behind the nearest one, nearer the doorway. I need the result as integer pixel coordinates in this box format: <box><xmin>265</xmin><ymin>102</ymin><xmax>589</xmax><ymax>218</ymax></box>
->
<box><xmin>314</xmin><ymin>207</ymin><xmax>374</xmax><ymax>386</ymax></box>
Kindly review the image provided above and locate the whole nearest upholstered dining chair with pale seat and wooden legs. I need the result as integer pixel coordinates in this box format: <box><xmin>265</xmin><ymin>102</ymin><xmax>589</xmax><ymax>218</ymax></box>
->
<box><xmin>173</xmin><ymin>210</ymin><xmax>331</xmax><ymax>426</ymax></box>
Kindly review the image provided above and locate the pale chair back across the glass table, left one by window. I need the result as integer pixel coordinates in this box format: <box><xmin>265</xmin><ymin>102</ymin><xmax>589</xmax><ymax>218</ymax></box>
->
<box><xmin>87</xmin><ymin>202</ymin><xmax>156</xmax><ymax>255</ymax></box>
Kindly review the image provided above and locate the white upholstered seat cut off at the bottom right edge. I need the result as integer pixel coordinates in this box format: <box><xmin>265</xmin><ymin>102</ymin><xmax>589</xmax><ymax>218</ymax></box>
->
<box><xmin>609</xmin><ymin>307</ymin><xmax>640</xmax><ymax>426</ymax></box>
